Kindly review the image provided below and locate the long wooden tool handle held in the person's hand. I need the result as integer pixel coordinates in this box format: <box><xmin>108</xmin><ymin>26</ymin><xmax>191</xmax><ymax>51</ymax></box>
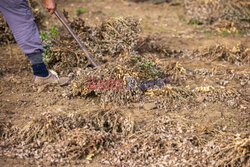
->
<box><xmin>54</xmin><ymin>9</ymin><xmax>99</xmax><ymax>67</ymax></box>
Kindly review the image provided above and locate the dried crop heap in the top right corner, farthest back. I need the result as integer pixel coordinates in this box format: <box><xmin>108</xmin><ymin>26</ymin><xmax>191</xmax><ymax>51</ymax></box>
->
<box><xmin>184</xmin><ymin>0</ymin><xmax>250</xmax><ymax>31</ymax></box>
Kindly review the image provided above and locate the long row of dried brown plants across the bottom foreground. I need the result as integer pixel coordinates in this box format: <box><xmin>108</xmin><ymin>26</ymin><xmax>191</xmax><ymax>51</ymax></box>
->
<box><xmin>0</xmin><ymin>110</ymin><xmax>250</xmax><ymax>166</ymax></box>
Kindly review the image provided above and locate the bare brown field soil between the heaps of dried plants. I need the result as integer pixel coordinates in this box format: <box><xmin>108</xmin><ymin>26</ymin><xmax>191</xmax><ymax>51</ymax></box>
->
<box><xmin>0</xmin><ymin>0</ymin><xmax>250</xmax><ymax>167</ymax></box>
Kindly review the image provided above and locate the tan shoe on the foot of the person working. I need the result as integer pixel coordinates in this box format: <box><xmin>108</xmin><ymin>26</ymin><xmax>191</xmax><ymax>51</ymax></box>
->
<box><xmin>34</xmin><ymin>71</ymin><xmax>70</xmax><ymax>86</ymax></box>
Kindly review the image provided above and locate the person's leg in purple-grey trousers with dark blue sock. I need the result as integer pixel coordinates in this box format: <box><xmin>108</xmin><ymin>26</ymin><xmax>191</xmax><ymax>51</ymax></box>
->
<box><xmin>0</xmin><ymin>0</ymin><xmax>49</xmax><ymax>77</ymax></box>
